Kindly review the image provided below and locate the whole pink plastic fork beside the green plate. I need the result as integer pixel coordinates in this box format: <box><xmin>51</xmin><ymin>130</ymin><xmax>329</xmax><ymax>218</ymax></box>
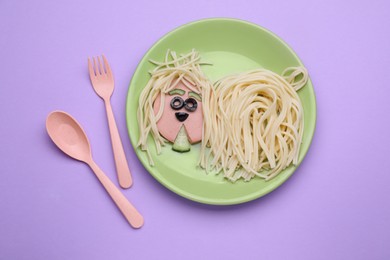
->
<box><xmin>88</xmin><ymin>55</ymin><xmax>133</xmax><ymax>188</ymax></box>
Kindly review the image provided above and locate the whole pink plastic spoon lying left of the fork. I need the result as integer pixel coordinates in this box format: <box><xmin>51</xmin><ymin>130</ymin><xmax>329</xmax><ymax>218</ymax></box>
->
<box><xmin>46</xmin><ymin>111</ymin><xmax>144</xmax><ymax>228</ymax></box>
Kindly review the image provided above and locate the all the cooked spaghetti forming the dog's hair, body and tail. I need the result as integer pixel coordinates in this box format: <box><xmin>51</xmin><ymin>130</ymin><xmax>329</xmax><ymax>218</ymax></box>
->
<box><xmin>137</xmin><ymin>50</ymin><xmax>308</xmax><ymax>182</ymax></box>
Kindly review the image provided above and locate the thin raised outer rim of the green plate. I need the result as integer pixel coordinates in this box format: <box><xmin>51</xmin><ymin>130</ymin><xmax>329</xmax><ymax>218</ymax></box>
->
<box><xmin>125</xmin><ymin>17</ymin><xmax>317</xmax><ymax>205</ymax></box>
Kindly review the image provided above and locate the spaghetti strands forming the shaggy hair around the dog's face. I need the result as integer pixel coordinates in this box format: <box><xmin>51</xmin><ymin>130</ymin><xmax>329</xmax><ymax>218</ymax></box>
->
<box><xmin>137</xmin><ymin>50</ymin><xmax>212</xmax><ymax>165</ymax></box>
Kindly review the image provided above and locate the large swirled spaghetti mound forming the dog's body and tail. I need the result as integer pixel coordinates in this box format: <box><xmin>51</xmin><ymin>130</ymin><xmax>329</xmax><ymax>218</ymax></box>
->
<box><xmin>200</xmin><ymin>67</ymin><xmax>308</xmax><ymax>182</ymax></box>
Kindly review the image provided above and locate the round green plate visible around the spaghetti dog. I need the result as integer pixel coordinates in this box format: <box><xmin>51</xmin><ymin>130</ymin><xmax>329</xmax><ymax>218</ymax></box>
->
<box><xmin>126</xmin><ymin>19</ymin><xmax>316</xmax><ymax>205</ymax></box>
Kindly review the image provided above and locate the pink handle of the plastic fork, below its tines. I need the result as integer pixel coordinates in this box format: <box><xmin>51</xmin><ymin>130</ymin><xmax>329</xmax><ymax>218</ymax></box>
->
<box><xmin>104</xmin><ymin>100</ymin><xmax>133</xmax><ymax>189</ymax></box>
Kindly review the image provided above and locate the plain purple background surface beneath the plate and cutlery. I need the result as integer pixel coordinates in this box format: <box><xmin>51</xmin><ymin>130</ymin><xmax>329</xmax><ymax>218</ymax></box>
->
<box><xmin>0</xmin><ymin>0</ymin><xmax>390</xmax><ymax>260</ymax></box>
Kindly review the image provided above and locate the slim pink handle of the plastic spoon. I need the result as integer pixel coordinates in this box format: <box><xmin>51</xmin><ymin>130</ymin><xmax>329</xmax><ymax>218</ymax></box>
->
<box><xmin>88</xmin><ymin>160</ymin><xmax>144</xmax><ymax>228</ymax></box>
